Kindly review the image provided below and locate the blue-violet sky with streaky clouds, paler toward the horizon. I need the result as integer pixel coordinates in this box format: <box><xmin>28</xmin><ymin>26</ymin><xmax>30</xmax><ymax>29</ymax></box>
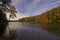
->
<box><xmin>7</xmin><ymin>0</ymin><xmax>60</xmax><ymax>19</ymax></box>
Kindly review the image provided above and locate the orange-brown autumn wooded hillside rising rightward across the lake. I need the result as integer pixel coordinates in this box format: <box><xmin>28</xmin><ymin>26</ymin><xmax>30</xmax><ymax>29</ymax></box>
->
<box><xmin>18</xmin><ymin>7</ymin><xmax>60</xmax><ymax>24</ymax></box>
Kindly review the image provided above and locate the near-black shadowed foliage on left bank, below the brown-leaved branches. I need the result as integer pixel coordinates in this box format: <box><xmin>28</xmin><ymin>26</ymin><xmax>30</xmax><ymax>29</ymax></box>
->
<box><xmin>0</xmin><ymin>9</ymin><xmax>8</xmax><ymax>35</ymax></box>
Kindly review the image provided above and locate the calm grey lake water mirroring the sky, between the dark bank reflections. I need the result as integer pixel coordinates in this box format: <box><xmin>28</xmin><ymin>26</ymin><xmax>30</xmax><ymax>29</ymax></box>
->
<box><xmin>7</xmin><ymin>22</ymin><xmax>60</xmax><ymax>40</ymax></box>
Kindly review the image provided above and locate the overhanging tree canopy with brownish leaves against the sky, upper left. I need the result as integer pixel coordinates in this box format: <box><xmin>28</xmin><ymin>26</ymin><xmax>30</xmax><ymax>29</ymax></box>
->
<box><xmin>0</xmin><ymin>0</ymin><xmax>17</xmax><ymax>18</ymax></box>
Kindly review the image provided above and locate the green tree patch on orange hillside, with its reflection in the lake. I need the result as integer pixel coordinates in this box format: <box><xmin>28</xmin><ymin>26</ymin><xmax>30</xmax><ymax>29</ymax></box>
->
<box><xmin>48</xmin><ymin>9</ymin><xmax>57</xmax><ymax>31</ymax></box>
